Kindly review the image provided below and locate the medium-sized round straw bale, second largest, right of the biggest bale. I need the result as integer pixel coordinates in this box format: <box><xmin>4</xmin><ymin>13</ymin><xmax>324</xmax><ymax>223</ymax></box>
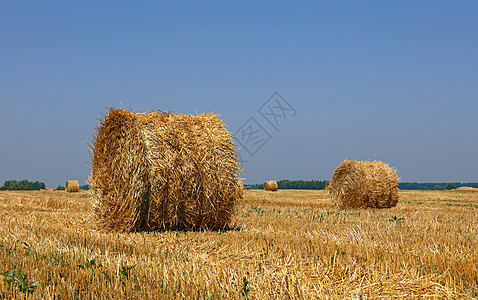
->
<box><xmin>327</xmin><ymin>160</ymin><xmax>399</xmax><ymax>208</ymax></box>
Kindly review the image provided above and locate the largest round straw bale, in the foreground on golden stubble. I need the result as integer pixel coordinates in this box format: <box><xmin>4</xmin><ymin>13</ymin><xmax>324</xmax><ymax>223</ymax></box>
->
<box><xmin>89</xmin><ymin>108</ymin><xmax>239</xmax><ymax>232</ymax></box>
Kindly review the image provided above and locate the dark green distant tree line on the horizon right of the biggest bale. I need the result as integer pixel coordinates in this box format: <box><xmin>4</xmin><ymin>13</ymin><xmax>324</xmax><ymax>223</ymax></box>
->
<box><xmin>246</xmin><ymin>180</ymin><xmax>478</xmax><ymax>190</ymax></box>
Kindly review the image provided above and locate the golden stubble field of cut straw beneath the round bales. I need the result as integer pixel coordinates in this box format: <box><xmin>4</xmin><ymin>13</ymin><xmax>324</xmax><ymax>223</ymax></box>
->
<box><xmin>0</xmin><ymin>190</ymin><xmax>478</xmax><ymax>299</ymax></box>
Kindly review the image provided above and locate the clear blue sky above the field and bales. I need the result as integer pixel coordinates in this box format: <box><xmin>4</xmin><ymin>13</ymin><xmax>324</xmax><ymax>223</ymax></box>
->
<box><xmin>0</xmin><ymin>0</ymin><xmax>478</xmax><ymax>187</ymax></box>
